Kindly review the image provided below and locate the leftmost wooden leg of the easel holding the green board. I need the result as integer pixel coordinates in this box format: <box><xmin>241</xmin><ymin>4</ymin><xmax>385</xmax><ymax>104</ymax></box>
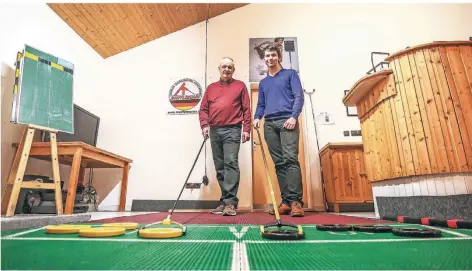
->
<box><xmin>5</xmin><ymin>127</ymin><xmax>35</xmax><ymax>216</ymax></box>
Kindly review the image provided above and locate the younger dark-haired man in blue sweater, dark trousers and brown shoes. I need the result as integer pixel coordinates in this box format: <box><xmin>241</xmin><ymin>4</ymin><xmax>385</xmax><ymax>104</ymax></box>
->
<box><xmin>253</xmin><ymin>46</ymin><xmax>304</xmax><ymax>216</ymax></box>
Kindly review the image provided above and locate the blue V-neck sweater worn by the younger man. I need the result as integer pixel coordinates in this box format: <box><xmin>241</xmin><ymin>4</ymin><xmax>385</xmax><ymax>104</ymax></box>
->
<box><xmin>254</xmin><ymin>69</ymin><xmax>304</xmax><ymax>120</ymax></box>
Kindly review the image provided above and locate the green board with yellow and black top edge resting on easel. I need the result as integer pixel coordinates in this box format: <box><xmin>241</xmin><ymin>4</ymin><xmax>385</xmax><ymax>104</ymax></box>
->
<box><xmin>11</xmin><ymin>45</ymin><xmax>74</xmax><ymax>133</ymax></box>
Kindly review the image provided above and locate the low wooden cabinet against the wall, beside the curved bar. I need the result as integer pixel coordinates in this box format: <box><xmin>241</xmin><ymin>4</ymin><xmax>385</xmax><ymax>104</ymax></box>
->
<box><xmin>320</xmin><ymin>142</ymin><xmax>373</xmax><ymax>212</ymax></box>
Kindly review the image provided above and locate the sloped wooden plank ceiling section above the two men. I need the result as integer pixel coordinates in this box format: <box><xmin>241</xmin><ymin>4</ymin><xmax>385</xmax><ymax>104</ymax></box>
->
<box><xmin>48</xmin><ymin>3</ymin><xmax>247</xmax><ymax>58</ymax></box>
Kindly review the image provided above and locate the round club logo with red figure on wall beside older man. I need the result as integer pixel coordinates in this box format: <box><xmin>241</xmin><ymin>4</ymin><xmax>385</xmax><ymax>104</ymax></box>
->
<box><xmin>167</xmin><ymin>78</ymin><xmax>202</xmax><ymax>115</ymax></box>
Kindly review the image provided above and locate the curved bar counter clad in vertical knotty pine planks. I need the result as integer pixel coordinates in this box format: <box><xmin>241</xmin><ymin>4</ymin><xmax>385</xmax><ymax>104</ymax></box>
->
<box><xmin>343</xmin><ymin>41</ymin><xmax>472</xmax><ymax>184</ymax></box>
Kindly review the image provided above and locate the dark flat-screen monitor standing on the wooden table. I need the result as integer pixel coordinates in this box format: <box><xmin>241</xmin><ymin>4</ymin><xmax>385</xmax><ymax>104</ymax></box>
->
<box><xmin>41</xmin><ymin>104</ymin><xmax>100</xmax><ymax>146</ymax></box>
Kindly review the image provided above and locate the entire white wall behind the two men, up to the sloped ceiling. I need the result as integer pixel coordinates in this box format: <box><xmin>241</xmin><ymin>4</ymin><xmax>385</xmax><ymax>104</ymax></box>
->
<box><xmin>2</xmin><ymin>1</ymin><xmax>472</xmax><ymax>210</ymax></box>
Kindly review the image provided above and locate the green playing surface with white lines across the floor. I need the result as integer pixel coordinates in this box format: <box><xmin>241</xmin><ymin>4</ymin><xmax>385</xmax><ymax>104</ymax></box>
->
<box><xmin>1</xmin><ymin>224</ymin><xmax>472</xmax><ymax>270</ymax></box>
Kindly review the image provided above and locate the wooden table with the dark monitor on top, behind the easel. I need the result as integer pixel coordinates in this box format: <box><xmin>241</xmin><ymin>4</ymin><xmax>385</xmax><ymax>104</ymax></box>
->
<box><xmin>13</xmin><ymin>142</ymin><xmax>133</xmax><ymax>214</ymax></box>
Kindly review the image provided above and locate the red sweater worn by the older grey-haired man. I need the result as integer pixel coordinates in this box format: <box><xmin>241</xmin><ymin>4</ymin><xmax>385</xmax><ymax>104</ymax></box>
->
<box><xmin>199</xmin><ymin>79</ymin><xmax>251</xmax><ymax>133</ymax></box>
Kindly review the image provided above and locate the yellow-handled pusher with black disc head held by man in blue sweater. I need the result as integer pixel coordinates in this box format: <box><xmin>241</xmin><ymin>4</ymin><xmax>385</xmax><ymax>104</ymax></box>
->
<box><xmin>256</xmin><ymin>128</ymin><xmax>305</xmax><ymax>240</ymax></box>
